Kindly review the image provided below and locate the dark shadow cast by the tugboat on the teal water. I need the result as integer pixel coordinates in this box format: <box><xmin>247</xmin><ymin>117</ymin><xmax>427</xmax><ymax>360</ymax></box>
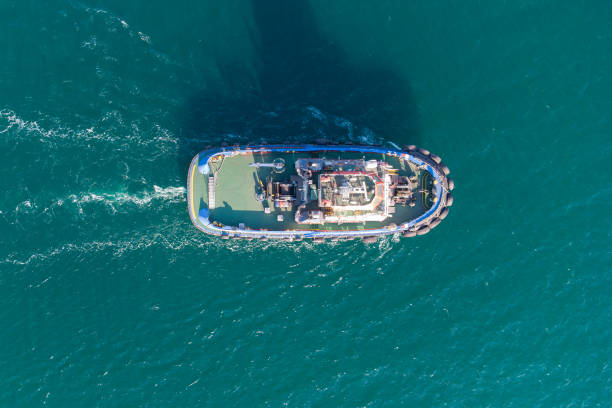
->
<box><xmin>179</xmin><ymin>0</ymin><xmax>418</xmax><ymax>168</ymax></box>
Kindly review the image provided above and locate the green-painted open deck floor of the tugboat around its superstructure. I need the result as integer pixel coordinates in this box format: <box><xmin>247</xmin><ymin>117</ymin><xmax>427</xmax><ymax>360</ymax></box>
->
<box><xmin>191</xmin><ymin>152</ymin><xmax>425</xmax><ymax>230</ymax></box>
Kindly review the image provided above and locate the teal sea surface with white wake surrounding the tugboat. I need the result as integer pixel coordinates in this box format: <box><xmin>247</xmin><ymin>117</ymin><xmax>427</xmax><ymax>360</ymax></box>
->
<box><xmin>0</xmin><ymin>0</ymin><xmax>612</xmax><ymax>408</ymax></box>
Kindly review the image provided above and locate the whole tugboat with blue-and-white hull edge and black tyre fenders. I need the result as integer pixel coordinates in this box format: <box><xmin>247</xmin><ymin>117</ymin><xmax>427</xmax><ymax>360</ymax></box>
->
<box><xmin>187</xmin><ymin>144</ymin><xmax>454</xmax><ymax>243</ymax></box>
